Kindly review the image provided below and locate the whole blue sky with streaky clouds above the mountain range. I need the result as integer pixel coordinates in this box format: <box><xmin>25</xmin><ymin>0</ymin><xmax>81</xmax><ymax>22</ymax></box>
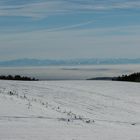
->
<box><xmin>0</xmin><ymin>0</ymin><xmax>140</xmax><ymax>60</ymax></box>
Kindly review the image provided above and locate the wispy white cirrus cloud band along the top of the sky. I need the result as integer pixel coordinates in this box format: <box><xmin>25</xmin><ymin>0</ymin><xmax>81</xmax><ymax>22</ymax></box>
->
<box><xmin>0</xmin><ymin>0</ymin><xmax>140</xmax><ymax>18</ymax></box>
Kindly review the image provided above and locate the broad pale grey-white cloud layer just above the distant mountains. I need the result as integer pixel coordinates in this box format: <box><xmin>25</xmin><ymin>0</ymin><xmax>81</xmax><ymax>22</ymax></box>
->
<box><xmin>0</xmin><ymin>26</ymin><xmax>140</xmax><ymax>59</ymax></box>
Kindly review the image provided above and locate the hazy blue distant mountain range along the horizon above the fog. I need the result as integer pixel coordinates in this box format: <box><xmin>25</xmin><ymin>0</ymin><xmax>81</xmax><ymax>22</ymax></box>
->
<box><xmin>0</xmin><ymin>58</ymin><xmax>140</xmax><ymax>67</ymax></box>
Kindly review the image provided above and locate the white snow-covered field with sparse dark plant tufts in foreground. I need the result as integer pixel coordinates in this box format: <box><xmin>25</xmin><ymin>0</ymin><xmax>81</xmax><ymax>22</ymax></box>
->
<box><xmin>0</xmin><ymin>81</ymin><xmax>140</xmax><ymax>140</ymax></box>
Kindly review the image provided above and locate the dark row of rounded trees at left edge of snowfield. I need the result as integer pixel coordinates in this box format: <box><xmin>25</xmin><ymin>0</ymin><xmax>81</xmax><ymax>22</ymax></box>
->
<box><xmin>0</xmin><ymin>75</ymin><xmax>37</xmax><ymax>81</ymax></box>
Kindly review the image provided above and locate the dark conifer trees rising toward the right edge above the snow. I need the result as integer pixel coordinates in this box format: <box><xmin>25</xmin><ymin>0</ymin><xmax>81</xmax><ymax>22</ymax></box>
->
<box><xmin>113</xmin><ymin>72</ymin><xmax>140</xmax><ymax>82</ymax></box>
